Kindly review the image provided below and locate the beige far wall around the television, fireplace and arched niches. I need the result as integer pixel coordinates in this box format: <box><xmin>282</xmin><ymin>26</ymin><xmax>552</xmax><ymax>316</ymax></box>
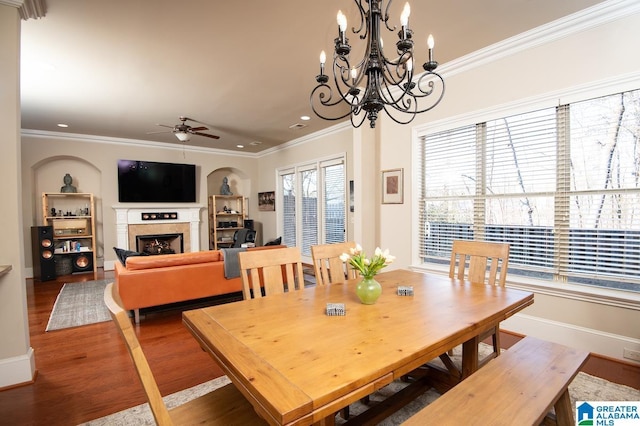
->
<box><xmin>22</xmin><ymin>136</ymin><xmax>258</xmax><ymax>269</ymax></box>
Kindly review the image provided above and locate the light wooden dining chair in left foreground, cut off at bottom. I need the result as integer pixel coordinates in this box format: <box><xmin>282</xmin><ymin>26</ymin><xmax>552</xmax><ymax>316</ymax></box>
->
<box><xmin>104</xmin><ymin>283</ymin><xmax>267</xmax><ymax>426</ymax></box>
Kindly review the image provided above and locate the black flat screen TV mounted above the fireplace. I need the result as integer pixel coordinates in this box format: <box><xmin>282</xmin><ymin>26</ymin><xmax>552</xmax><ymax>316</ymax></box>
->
<box><xmin>118</xmin><ymin>160</ymin><xmax>196</xmax><ymax>203</ymax></box>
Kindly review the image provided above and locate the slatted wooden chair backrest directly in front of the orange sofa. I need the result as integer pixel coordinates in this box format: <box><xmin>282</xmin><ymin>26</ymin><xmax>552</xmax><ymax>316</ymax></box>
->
<box><xmin>238</xmin><ymin>247</ymin><xmax>304</xmax><ymax>299</ymax></box>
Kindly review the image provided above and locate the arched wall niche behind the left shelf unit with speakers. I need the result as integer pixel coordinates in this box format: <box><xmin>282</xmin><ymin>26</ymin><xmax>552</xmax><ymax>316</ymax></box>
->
<box><xmin>28</xmin><ymin>156</ymin><xmax>104</xmax><ymax>266</ymax></box>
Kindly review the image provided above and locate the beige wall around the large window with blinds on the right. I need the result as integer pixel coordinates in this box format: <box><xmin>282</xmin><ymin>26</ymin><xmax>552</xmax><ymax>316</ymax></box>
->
<box><xmin>380</xmin><ymin>7</ymin><xmax>640</xmax><ymax>358</ymax></box>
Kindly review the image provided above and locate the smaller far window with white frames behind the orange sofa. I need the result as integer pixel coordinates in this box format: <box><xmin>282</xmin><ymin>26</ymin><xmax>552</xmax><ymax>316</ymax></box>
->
<box><xmin>276</xmin><ymin>157</ymin><xmax>346</xmax><ymax>257</ymax></box>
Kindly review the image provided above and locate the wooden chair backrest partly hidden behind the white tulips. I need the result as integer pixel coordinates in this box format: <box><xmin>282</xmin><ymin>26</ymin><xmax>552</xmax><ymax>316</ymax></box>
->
<box><xmin>311</xmin><ymin>241</ymin><xmax>358</xmax><ymax>285</ymax></box>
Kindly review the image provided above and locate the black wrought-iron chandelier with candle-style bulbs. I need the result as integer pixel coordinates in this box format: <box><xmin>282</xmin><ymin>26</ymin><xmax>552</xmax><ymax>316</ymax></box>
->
<box><xmin>310</xmin><ymin>0</ymin><xmax>444</xmax><ymax>128</ymax></box>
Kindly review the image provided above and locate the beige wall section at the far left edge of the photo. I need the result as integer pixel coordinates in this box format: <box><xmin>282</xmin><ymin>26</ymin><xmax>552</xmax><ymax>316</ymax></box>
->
<box><xmin>0</xmin><ymin>4</ymin><xmax>35</xmax><ymax>388</ymax></box>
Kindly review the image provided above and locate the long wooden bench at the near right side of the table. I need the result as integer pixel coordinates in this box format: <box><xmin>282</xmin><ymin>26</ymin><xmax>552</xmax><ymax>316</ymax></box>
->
<box><xmin>403</xmin><ymin>337</ymin><xmax>589</xmax><ymax>426</ymax></box>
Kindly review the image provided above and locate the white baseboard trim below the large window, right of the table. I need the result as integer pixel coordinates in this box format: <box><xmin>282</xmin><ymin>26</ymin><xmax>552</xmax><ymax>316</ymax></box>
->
<box><xmin>500</xmin><ymin>314</ymin><xmax>640</xmax><ymax>365</ymax></box>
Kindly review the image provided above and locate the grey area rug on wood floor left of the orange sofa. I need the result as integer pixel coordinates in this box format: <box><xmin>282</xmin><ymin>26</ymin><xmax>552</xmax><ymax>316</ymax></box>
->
<box><xmin>45</xmin><ymin>280</ymin><xmax>113</xmax><ymax>331</ymax></box>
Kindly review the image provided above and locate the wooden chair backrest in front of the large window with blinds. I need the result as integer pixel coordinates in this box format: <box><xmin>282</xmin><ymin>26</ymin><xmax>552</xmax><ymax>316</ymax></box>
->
<box><xmin>449</xmin><ymin>240</ymin><xmax>509</xmax><ymax>287</ymax></box>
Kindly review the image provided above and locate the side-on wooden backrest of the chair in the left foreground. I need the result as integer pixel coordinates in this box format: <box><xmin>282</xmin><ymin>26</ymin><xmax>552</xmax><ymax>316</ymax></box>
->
<box><xmin>104</xmin><ymin>283</ymin><xmax>173</xmax><ymax>426</ymax></box>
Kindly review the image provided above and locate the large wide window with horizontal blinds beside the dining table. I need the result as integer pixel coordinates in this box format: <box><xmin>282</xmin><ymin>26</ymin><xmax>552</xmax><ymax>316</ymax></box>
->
<box><xmin>419</xmin><ymin>90</ymin><xmax>640</xmax><ymax>292</ymax></box>
